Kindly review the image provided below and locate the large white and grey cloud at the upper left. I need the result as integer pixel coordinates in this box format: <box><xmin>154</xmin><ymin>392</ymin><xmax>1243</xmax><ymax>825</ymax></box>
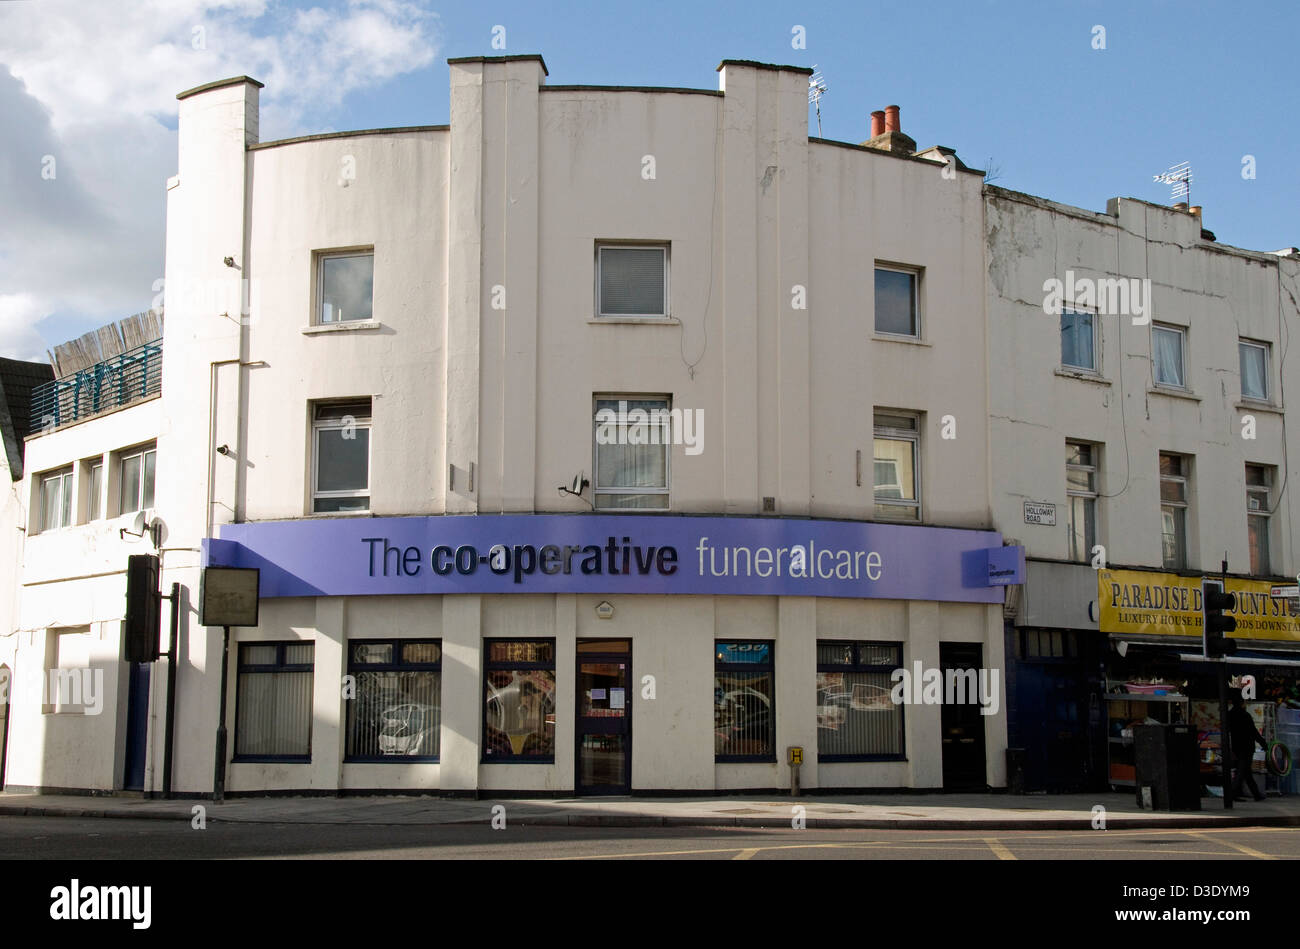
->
<box><xmin>0</xmin><ymin>0</ymin><xmax>437</xmax><ymax>356</ymax></box>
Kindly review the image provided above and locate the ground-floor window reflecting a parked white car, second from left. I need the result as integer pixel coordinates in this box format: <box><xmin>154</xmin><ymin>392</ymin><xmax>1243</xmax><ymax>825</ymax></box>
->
<box><xmin>347</xmin><ymin>640</ymin><xmax>442</xmax><ymax>762</ymax></box>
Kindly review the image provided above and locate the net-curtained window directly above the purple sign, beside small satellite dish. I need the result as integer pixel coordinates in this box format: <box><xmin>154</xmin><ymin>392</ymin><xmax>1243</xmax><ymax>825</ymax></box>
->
<box><xmin>594</xmin><ymin>397</ymin><xmax>672</xmax><ymax>511</ymax></box>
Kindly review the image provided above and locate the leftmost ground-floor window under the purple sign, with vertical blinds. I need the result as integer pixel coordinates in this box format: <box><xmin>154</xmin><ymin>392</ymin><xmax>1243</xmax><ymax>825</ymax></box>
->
<box><xmin>235</xmin><ymin>642</ymin><xmax>316</xmax><ymax>762</ymax></box>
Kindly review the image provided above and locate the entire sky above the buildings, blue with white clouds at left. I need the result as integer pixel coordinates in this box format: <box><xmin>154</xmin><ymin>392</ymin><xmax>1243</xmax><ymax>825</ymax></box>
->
<box><xmin>0</xmin><ymin>0</ymin><xmax>1300</xmax><ymax>358</ymax></box>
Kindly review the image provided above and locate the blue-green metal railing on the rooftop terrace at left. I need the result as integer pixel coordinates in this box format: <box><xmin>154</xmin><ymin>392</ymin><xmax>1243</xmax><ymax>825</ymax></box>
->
<box><xmin>31</xmin><ymin>339</ymin><xmax>163</xmax><ymax>432</ymax></box>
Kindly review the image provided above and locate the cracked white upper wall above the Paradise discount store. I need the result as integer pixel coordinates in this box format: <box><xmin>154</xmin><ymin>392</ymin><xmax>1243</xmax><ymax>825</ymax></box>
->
<box><xmin>987</xmin><ymin>189</ymin><xmax>1300</xmax><ymax>576</ymax></box>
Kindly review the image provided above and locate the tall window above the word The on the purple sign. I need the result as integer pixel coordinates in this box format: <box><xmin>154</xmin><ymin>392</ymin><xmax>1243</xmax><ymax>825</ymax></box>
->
<box><xmin>312</xmin><ymin>399</ymin><xmax>371</xmax><ymax>514</ymax></box>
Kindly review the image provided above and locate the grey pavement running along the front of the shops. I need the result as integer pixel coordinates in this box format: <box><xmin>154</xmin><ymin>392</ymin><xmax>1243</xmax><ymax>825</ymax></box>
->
<box><xmin>0</xmin><ymin>792</ymin><xmax>1300</xmax><ymax>831</ymax></box>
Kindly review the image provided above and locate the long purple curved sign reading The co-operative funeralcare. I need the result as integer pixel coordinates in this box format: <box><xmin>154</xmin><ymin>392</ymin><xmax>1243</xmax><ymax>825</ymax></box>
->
<box><xmin>207</xmin><ymin>515</ymin><xmax>1023</xmax><ymax>603</ymax></box>
